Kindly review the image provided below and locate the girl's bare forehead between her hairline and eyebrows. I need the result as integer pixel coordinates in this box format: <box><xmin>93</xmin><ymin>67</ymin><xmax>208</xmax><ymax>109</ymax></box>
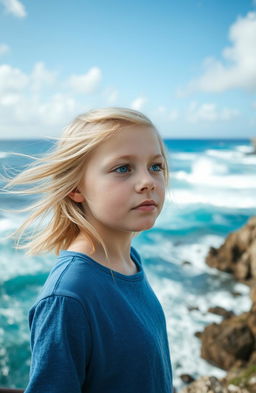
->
<box><xmin>92</xmin><ymin>125</ymin><xmax>161</xmax><ymax>157</ymax></box>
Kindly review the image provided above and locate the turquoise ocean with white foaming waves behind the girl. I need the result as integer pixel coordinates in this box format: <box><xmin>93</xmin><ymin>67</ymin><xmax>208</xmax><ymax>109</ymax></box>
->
<box><xmin>0</xmin><ymin>139</ymin><xmax>256</xmax><ymax>390</ymax></box>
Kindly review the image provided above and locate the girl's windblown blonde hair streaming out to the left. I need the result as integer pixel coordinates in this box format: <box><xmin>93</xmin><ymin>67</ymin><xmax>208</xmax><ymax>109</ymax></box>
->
<box><xmin>4</xmin><ymin>107</ymin><xmax>169</xmax><ymax>256</ymax></box>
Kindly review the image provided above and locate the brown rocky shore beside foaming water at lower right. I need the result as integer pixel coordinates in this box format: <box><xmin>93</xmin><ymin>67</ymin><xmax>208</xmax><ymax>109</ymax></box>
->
<box><xmin>179</xmin><ymin>216</ymin><xmax>256</xmax><ymax>393</ymax></box>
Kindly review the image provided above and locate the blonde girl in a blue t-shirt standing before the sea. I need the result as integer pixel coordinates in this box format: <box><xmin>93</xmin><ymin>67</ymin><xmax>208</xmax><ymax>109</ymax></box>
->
<box><xmin>4</xmin><ymin>107</ymin><xmax>172</xmax><ymax>393</ymax></box>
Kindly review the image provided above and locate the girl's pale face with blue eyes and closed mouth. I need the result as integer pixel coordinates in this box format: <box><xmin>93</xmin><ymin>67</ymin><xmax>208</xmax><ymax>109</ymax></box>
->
<box><xmin>71</xmin><ymin>126</ymin><xmax>165</xmax><ymax>233</ymax></box>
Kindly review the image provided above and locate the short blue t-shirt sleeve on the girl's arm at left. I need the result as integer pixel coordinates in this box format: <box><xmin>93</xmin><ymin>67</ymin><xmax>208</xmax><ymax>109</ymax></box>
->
<box><xmin>25</xmin><ymin>295</ymin><xmax>91</xmax><ymax>393</ymax></box>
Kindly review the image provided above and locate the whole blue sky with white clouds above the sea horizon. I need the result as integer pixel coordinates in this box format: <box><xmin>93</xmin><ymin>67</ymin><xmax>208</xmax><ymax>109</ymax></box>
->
<box><xmin>0</xmin><ymin>0</ymin><xmax>256</xmax><ymax>139</ymax></box>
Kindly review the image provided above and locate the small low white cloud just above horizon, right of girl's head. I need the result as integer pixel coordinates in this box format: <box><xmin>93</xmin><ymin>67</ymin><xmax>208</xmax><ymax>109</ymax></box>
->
<box><xmin>187</xmin><ymin>101</ymin><xmax>239</xmax><ymax>123</ymax></box>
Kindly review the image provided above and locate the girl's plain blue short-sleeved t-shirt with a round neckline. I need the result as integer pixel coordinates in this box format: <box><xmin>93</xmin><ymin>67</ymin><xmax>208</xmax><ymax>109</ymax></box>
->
<box><xmin>25</xmin><ymin>247</ymin><xmax>172</xmax><ymax>393</ymax></box>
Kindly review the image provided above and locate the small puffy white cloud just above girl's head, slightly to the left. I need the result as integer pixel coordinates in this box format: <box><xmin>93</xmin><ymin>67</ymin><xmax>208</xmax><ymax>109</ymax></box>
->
<box><xmin>67</xmin><ymin>67</ymin><xmax>102</xmax><ymax>94</ymax></box>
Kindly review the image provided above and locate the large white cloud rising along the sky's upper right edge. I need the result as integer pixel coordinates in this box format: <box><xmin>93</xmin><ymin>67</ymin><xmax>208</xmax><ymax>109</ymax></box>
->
<box><xmin>186</xmin><ymin>12</ymin><xmax>256</xmax><ymax>93</ymax></box>
